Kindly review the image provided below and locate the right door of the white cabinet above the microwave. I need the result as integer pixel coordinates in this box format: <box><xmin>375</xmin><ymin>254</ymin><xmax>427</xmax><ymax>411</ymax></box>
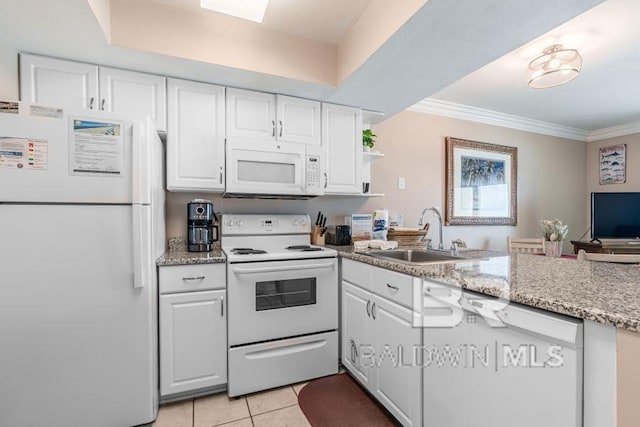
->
<box><xmin>276</xmin><ymin>95</ymin><xmax>321</xmax><ymax>145</ymax></box>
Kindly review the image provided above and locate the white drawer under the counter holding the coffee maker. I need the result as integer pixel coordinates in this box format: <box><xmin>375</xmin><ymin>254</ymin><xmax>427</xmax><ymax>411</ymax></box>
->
<box><xmin>159</xmin><ymin>263</ymin><xmax>227</xmax><ymax>294</ymax></box>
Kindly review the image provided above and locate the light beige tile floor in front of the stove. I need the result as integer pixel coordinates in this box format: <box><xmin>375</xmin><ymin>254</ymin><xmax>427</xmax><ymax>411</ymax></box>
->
<box><xmin>153</xmin><ymin>382</ymin><xmax>311</xmax><ymax>427</ymax></box>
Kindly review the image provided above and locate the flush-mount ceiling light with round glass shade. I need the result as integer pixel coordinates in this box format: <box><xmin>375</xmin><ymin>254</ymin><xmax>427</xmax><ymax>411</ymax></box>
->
<box><xmin>526</xmin><ymin>44</ymin><xmax>582</xmax><ymax>89</ymax></box>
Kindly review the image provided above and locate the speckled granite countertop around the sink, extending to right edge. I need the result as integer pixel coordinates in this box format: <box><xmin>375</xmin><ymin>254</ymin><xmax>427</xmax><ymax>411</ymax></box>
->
<box><xmin>332</xmin><ymin>246</ymin><xmax>640</xmax><ymax>332</ymax></box>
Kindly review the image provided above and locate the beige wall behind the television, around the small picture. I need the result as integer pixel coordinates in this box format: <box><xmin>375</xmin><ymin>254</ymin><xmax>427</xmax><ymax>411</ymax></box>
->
<box><xmin>585</xmin><ymin>133</ymin><xmax>640</xmax><ymax>231</ymax></box>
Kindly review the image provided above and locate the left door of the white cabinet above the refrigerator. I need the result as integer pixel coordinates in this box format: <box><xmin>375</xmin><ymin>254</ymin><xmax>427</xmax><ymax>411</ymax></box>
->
<box><xmin>20</xmin><ymin>53</ymin><xmax>99</xmax><ymax>109</ymax></box>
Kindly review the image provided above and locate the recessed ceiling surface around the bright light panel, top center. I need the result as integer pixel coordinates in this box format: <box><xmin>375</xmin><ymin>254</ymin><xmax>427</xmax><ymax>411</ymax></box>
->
<box><xmin>151</xmin><ymin>0</ymin><xmax>372</xmax><ymax>45</ymax></box>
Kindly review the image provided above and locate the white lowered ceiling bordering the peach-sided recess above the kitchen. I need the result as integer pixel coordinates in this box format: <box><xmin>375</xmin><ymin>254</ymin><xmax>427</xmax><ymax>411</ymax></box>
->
<box><xmin>0</xmin><ymin>0</ymin><xmax>604</xmax><ymax>117</ymax></box>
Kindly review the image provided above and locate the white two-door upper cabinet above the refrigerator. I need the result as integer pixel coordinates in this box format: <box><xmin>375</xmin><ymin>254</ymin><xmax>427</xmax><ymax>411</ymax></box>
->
<box><xmin>20</xmin><ymin>54</ymin><xmax>167</xmax><ymax>131</ymax></box>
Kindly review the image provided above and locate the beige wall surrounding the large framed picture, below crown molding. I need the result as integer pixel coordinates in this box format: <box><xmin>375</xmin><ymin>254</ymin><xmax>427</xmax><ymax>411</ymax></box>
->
<box><xmin>363</xmin><ymin>111</ymin><xmax>586</xmax><ymax>252</ymax></box>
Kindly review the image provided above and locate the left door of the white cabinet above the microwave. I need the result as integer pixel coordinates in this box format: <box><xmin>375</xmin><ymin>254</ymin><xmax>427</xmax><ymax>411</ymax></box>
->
<box><xmin>227</xmin><ymin>88</ymin><xmax>276</xmax><ymax>140</ymax></box>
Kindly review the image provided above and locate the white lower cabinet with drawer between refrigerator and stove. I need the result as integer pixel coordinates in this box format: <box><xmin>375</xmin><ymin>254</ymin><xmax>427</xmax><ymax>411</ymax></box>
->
<box><xmin>159</xmin><ymin>264</ymin><xmax>227</xmax><ymax>397</ymax></box>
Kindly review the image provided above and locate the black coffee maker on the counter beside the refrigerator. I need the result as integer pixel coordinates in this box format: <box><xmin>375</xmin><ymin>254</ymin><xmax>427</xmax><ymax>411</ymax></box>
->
<box><xmin>187</xmin><ymin>199</ymin><xmax>218</xmax><ymax>252</ymax></box>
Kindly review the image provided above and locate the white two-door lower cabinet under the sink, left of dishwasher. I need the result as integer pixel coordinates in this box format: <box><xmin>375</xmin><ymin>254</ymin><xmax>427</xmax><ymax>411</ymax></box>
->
<box><xmin>341</xmin><ymin>260</ymin><xmax>422</xmax><ymax>426</ymax></box>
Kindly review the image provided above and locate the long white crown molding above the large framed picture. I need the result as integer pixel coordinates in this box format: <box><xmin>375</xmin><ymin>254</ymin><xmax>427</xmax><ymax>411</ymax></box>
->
<box><xmin>407</xmin><ymin>98</ymin><xmax>589</xmax><ymax>142</ymax></box>
